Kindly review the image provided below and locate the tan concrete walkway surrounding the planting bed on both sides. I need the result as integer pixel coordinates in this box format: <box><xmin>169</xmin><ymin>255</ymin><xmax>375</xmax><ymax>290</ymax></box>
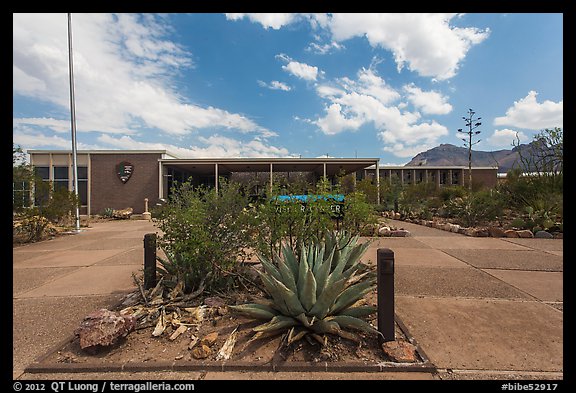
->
<box><xmin>13</xmin><ymin>220</ymin><xmax>563</xmax><ymax>379</ymax></box>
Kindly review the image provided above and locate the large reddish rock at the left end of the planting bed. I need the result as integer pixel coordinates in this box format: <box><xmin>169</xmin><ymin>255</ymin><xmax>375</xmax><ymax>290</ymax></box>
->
<box><xmin>74</xmin><ymin>308</ymin><xmax>136</xmax><ymax>349</ymax></box>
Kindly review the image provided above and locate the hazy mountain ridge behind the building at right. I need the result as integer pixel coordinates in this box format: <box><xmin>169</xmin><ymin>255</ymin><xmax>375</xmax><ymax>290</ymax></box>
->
<box><xmin>406</xmin><ymin>143</ymin><xmax>530</xmax><ymax>173</ymax></box>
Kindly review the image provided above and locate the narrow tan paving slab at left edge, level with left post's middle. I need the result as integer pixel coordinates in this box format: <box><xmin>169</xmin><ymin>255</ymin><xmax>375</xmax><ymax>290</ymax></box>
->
<box><xmin>15</xmin><ymin>249</ymin><xmax>123</xmax><ymax>268</ymax></box>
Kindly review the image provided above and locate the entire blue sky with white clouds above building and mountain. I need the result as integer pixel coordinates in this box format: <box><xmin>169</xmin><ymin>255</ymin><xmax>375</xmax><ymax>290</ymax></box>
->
<box><xmin>13</xmin><ymin>13</ymin><xmax>563</xmax><ymax>165</ymax></box>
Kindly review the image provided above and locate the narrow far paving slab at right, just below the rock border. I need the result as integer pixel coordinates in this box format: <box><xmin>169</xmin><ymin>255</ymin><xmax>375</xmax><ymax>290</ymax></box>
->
<box><xmin>418</xmin><ymin>236</ymin><xmax>528</xmax><ymax>250</ymax></box>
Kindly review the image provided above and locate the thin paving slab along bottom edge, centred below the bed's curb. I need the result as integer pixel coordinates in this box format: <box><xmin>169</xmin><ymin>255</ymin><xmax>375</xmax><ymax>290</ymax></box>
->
<box><xmin>204</xmin><ymin>371</ymin><xmax>434</xmax><ymax>381</ymax></box>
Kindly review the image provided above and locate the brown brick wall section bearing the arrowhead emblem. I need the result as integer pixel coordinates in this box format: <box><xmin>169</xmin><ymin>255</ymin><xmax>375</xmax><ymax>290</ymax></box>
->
<box><xmin>90</xmin><ymin>154</ymin><xmax>161</xmax><ymax>214</ymax></box>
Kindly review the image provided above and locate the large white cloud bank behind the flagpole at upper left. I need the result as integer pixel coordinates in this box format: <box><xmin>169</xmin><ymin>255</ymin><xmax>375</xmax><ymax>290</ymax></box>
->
<box><xmin>13</xmin><ymin>14</ymin><xmax>274</xmax><ymax>136</ymax></box>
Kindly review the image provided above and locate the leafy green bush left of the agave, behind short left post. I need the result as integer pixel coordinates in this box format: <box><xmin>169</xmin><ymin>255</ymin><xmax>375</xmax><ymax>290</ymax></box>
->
<box><xmin>155</xmin><ymin>179</ymin><xmax>254</xmax><ymax>293</ymax></box>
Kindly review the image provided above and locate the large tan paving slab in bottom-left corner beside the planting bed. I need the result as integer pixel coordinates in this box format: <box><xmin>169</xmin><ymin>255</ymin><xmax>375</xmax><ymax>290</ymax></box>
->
<box><xmin>12</xmin><ymin>295</ymin><xmax>120</xmax><ymax>379</ymax></box>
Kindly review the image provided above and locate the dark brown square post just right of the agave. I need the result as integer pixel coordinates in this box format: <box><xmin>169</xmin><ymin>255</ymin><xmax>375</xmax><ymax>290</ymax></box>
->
<box><xmin>376</xmin><ymin>248</ymin><xmax>395</xmax><ymax>344</ymax></box>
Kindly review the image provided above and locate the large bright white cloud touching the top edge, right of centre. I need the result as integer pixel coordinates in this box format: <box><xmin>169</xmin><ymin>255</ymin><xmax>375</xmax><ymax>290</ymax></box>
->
<box><xmin>227</xmin><ymin>13</ymin><xmax>490</xmax><ymax>80</ymax></box>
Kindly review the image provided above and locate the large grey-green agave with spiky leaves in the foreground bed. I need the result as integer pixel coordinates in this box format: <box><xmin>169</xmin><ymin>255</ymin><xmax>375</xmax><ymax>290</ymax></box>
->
<box><xmin>230</xmin><ymin>232</ymin><xmax>379</xmax><ymax>344</ymax></box>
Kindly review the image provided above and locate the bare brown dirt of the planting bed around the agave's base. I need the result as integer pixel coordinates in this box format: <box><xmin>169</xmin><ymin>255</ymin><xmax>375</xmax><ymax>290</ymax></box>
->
<box><xmin>35</xmin><ymin>290</ymin><xmax>426</xmax><ymax>366</ymax></box>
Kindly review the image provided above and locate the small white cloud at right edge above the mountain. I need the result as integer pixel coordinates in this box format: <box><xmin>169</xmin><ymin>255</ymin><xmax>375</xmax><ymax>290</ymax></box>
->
<box><xmin>494</xmin><ymin>90</ymin><xmax>564</xmax><ymax>130</ymax></box>
